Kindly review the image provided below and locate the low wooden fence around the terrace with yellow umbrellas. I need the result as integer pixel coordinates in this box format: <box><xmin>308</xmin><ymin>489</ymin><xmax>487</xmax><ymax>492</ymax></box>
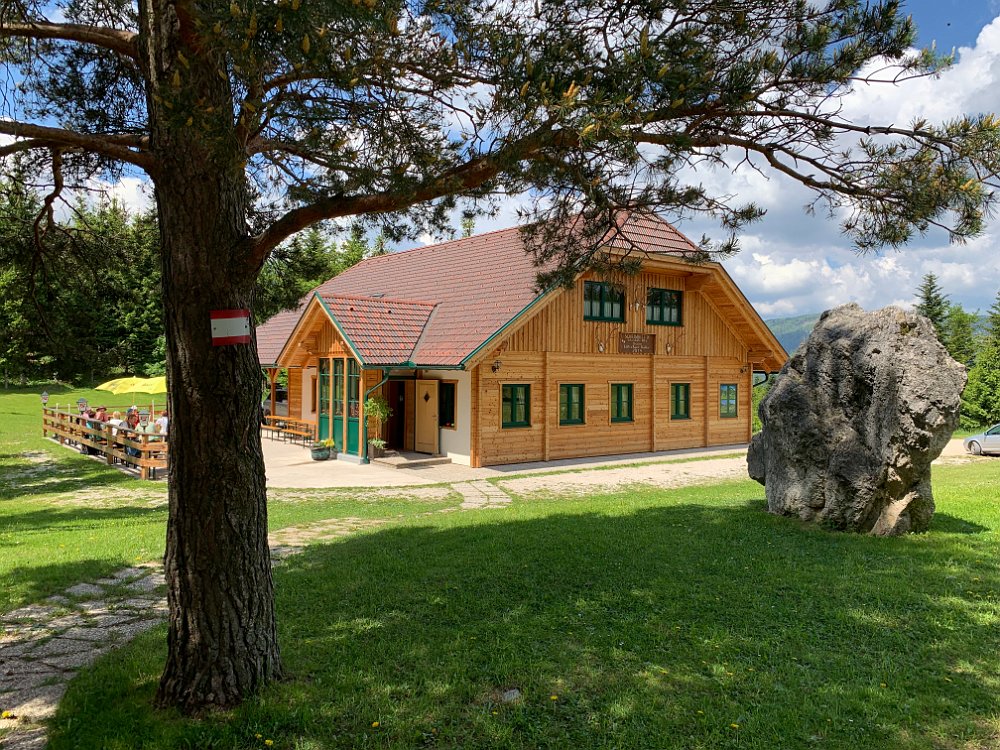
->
<box><xmin>42</xmin><ymin>406</ymin><xmax>168</xmax><ymax>479</ymax></box>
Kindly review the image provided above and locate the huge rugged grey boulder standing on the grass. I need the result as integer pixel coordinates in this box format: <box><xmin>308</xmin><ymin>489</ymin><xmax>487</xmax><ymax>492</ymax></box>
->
<box><xmin>747</xmin><ymin>305</ymin><xmax>966</xmax><ymax>536</ymax></box>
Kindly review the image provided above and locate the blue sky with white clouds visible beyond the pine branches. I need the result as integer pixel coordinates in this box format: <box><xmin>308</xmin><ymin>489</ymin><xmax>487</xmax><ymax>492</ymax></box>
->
<box><xmin>56</xmin><ymin>0</ymin><xmax>1000</xmax><ymax>318</ymax></box>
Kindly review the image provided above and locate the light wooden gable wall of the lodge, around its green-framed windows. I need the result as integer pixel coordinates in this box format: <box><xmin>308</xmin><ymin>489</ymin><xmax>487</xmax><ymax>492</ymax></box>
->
<box><xmin>472</xmin><ymin>272</ymin><xmax>752</xmax><ymax>466</ymax></box>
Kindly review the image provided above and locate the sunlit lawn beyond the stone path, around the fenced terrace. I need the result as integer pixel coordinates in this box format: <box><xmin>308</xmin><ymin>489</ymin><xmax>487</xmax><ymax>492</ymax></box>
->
<box><xmin>0</xmin><ymin>385</ymin><xmax>459</xmax><ymax>613</ymax></box>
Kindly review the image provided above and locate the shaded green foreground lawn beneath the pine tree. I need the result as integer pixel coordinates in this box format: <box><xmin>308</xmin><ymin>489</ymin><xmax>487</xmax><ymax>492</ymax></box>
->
<box><xmin>51</xmin><ymin>504</ymin><xmax>1000</xmax><ymax>749</ymax></box>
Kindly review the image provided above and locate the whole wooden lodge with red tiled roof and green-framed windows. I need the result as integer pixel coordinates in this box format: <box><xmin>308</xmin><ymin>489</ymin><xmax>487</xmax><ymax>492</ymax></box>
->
<box><xmin>257</xmin><ymin>215</ymin><xmax>787</xmax><ymax>466</ymax></box>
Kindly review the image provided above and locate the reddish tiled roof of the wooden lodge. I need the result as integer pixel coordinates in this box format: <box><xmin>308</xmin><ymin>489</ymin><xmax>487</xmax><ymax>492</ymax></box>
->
<box><xmin>257</xmin><ymin>213</ymin><xmax>697</xmax><ymax>366</ymax></box>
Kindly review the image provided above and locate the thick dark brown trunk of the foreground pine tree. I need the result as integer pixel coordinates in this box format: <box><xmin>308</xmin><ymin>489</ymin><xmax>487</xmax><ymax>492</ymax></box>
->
<box><xmin>140</xmin><ymin>0</ymin><xmax>282</xmax><ymax>713</ymax></box>
